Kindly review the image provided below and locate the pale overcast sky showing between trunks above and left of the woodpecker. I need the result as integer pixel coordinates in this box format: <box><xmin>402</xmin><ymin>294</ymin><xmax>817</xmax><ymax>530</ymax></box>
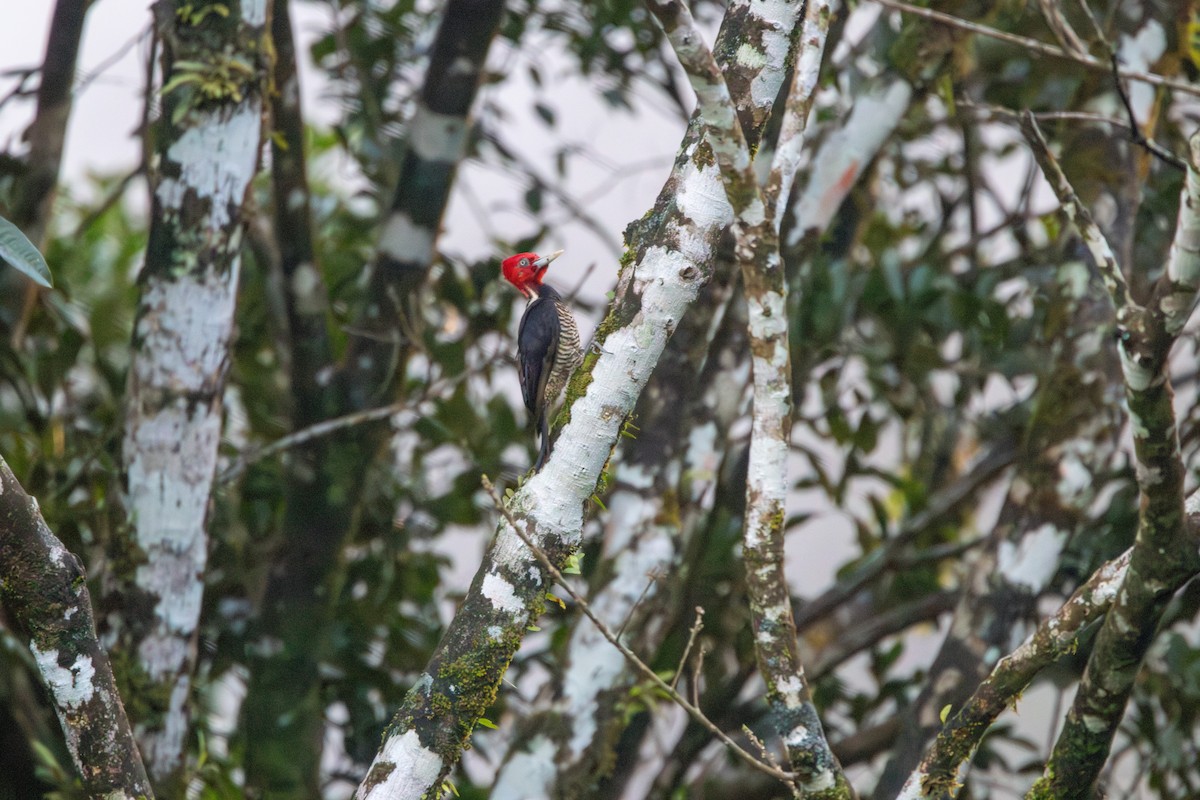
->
<box><xmin>0</xmin><ymin>0</ymin><xmax>683</xmax><ymax>275</ymax></box>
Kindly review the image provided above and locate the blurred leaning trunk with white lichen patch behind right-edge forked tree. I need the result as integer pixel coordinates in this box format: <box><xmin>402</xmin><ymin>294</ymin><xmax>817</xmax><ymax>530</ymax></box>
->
<box><xmin>874</xmin><ymin>14</ymin><xmax>1176</xmax><ymax>800</ymax></box>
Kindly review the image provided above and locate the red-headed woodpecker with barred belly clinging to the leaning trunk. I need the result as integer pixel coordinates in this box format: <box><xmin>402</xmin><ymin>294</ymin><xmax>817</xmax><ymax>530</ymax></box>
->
<box><xmin>500</xmin><ymin>251</ymin><xmax>583</xmax><ymax>471</ymax></box>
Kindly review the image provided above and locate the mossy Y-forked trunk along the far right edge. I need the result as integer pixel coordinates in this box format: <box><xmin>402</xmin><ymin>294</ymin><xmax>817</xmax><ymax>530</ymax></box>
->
<box><xmin>1022</xmin><ymin>120</ymin><xmax>1200</xmax><ymax>798</ymax></box>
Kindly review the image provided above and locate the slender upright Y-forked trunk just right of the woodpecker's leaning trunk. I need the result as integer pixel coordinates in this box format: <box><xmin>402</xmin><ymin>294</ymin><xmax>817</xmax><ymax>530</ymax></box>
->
<box><xmin>648</xmin><ymin>0</ymin><xmax>852</xmax><ymax>798</ymax></box>
